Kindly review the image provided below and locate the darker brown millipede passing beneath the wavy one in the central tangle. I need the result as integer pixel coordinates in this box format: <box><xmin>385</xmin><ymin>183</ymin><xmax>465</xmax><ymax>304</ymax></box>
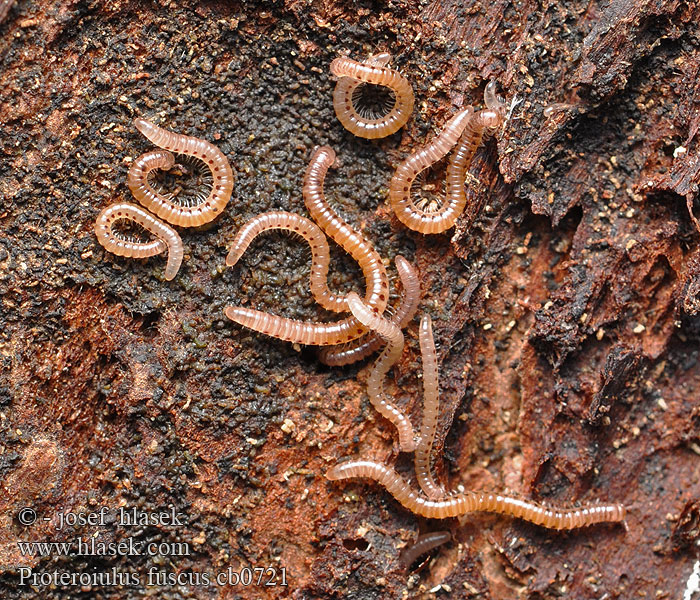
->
<box><xmin>318</xmin><ymin>255</ymin><xmax>420</xmax><ymax>367</ymax></box>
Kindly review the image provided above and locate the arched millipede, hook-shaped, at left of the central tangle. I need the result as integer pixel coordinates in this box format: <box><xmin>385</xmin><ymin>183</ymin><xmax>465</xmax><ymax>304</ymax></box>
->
<box><xmin>226</xmin><ymin>211</ymin><xmax>347</xmax><ymax>312</ymax></box>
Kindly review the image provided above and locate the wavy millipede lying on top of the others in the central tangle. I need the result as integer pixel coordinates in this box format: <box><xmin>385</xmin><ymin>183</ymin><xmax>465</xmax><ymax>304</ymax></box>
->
<box><xmin>348</xmin><ymin>292</ymin><xmax>416</xmax><ymax>452</ymax></box>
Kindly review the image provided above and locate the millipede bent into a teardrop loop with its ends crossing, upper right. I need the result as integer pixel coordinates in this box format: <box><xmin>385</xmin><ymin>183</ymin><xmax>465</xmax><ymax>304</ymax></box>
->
<box><xmin>389</xmin><ymin>81</ymin><xmax>506</xmax><ymax>234</ymax></box>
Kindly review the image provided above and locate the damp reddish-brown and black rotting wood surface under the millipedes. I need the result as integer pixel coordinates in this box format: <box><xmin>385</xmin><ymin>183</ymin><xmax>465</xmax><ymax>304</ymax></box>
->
<box><xmin>0</xmin><ymin>0</ymin><xmax>700</xmax><ymax>600</ymax></box>
